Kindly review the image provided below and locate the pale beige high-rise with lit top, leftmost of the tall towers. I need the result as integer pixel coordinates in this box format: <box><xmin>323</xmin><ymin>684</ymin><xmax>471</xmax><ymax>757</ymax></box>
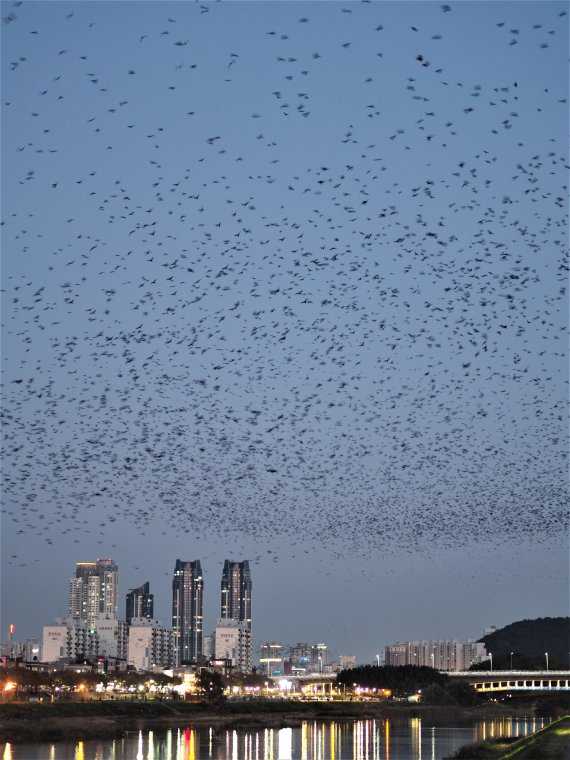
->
<box><xmin>69</xmin><ymin>559</ymin><xmax>119</xmax><ymax>624</ymax></box>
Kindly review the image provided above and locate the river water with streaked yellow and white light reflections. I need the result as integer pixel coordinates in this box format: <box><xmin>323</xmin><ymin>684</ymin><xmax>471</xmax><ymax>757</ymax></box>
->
<box><xmin>2</xmin><ymin>718</ymin><xmax>548</xmax><ymax>760</ymax></box>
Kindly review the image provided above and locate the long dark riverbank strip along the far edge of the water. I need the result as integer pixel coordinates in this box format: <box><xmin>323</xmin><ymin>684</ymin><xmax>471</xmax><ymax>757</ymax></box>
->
<box><xmin>0</xmin><ymin>700</ymin><xmax>560</xmax><ymax>743</ymax></box>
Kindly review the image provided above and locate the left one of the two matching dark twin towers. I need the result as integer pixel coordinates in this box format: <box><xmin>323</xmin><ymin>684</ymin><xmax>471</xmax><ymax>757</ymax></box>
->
<box><xmin>172</xmin><ymin>559</ymin><xmax>204</xmax><ymax>666</ymax></box>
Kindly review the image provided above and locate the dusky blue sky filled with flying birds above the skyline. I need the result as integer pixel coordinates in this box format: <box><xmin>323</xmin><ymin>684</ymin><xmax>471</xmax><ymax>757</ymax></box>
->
<box><xmin>1</xmin><ymin>0</ymin><xmax>569</xmax><ymax>662</ymax></box>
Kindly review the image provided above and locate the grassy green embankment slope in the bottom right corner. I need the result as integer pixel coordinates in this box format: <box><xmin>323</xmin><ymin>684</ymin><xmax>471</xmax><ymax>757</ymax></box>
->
<box><xmin>446</xmin><ymin>715</ymin><xmax>570</xmax><ymax>760</ymax></box>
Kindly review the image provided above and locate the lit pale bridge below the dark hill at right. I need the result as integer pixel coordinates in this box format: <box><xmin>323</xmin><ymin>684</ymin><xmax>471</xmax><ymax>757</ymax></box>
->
<box><xmin>447</xmin><ymin>670</ymin><xmax>570</xmax><ymax>694</ymax></box>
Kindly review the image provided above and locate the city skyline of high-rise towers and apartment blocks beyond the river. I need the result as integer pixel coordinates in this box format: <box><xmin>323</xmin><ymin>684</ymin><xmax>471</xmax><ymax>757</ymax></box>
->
<box><xmin>8</xmin><ymin>558</ymin><xmax>552</xmax><ymax>672</ymax></box>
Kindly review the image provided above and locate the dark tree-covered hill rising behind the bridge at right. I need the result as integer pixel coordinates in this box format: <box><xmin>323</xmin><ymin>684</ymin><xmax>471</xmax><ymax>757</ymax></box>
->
<box><xmin>479</xmin><ymin>617</ymin><xmax>570</xmax><ymax>668</ymax></box>
